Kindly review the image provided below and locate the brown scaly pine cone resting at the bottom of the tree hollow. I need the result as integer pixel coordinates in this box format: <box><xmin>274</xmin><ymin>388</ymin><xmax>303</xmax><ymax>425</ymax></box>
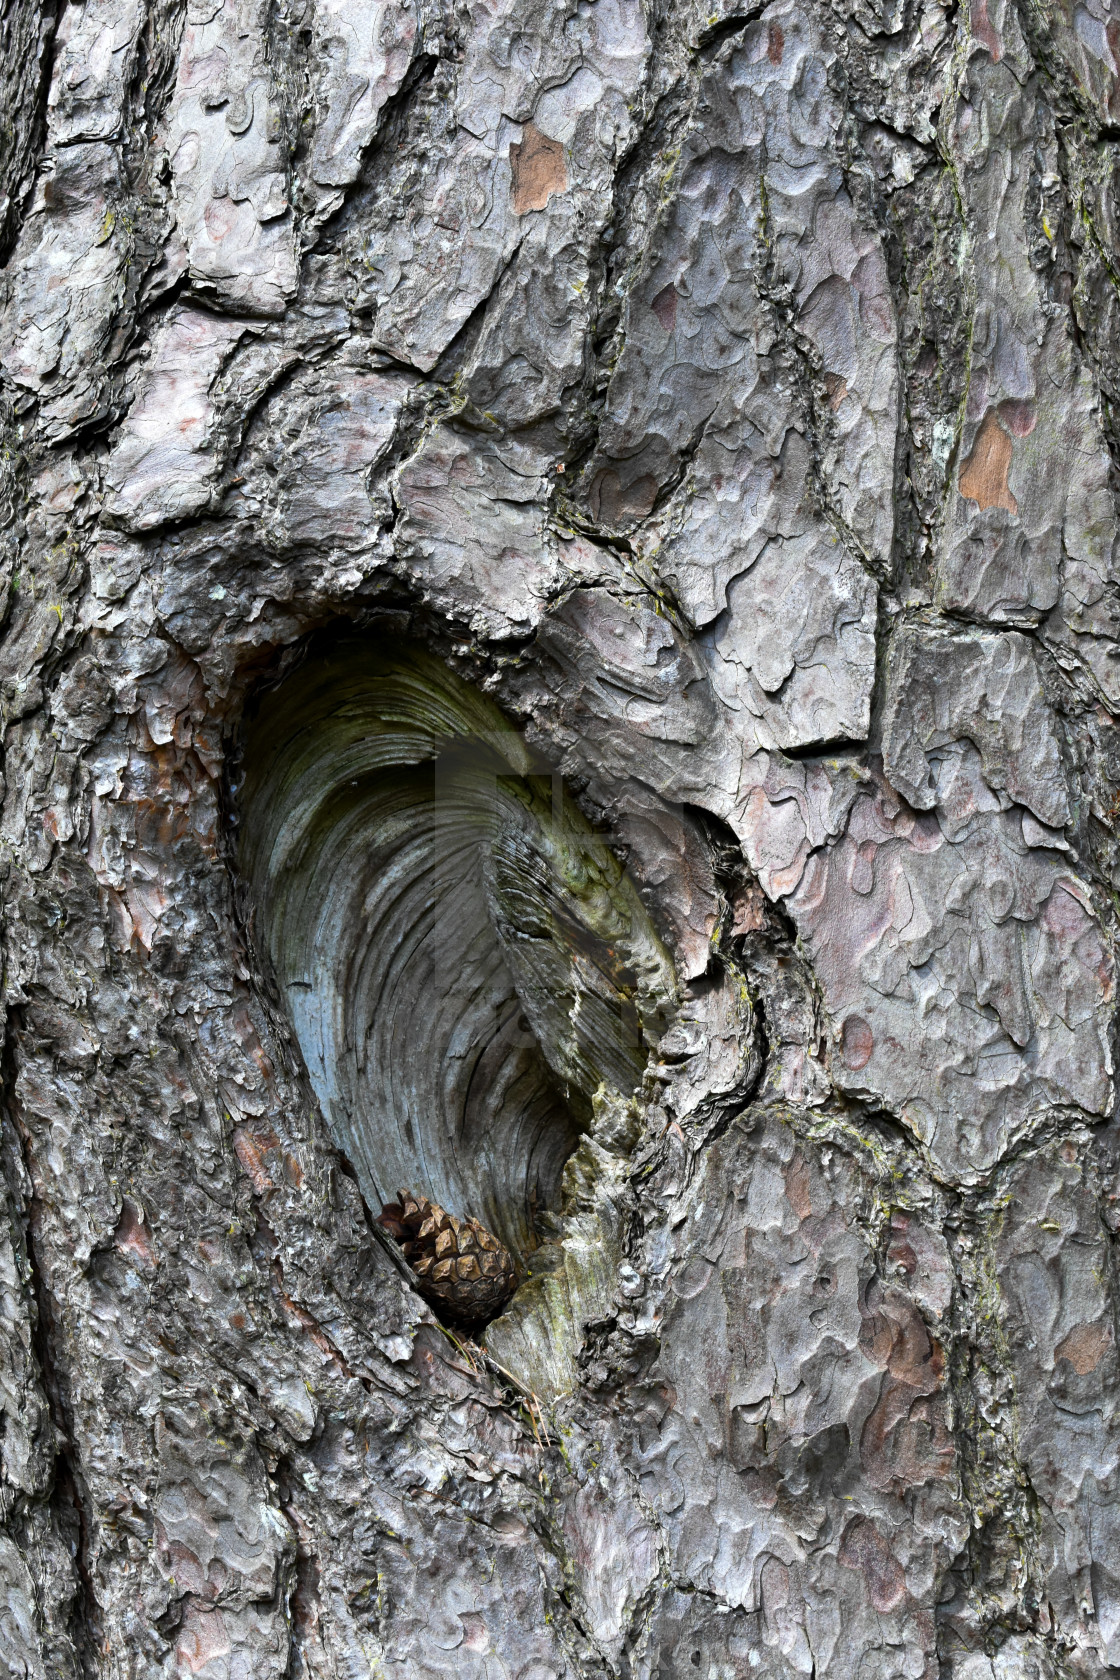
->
<box><xmin>378</xmin><ymin>1189</ymin><xmax>517</xmax><ymax>1329</ymax></box>
